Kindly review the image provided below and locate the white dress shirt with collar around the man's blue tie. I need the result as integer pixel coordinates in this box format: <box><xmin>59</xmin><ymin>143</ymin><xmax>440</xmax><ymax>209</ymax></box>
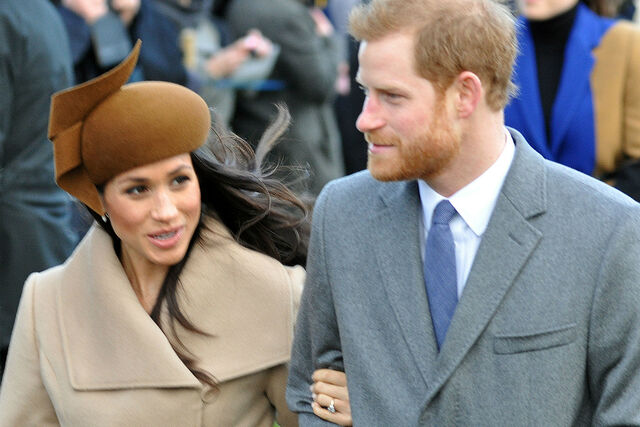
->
<box><xmin>418</xmin><ymin>129</ymin><xmax>515</xmax><ymax>298</ymax></box>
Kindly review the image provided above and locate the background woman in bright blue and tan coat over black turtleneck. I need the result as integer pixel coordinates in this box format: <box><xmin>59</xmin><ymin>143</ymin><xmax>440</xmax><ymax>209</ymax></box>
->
<box><xmin>505</xmin><ymin>0</ymin><xmax>640</xmax><ymax>199</ymax></box>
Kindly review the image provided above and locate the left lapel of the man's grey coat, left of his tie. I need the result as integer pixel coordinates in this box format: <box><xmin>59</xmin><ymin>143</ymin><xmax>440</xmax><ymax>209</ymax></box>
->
<box><xmin>371</xmin><ymin>181</ymin><xmax>438</xmax><ymax>383</ymax></box>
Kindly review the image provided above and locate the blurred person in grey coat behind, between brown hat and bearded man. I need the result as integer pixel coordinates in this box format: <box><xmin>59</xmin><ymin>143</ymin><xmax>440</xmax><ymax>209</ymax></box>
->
<box><xmin>224</xmin><ymin>0</ymin><xmax>344</xmax><ymax>195</ymax></box>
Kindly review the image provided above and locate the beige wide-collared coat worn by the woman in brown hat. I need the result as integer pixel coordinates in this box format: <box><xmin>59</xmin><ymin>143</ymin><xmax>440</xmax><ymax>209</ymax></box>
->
<box><xmin>0</xmin><ymin>221</ymin><xmax>304</xmax><ymax>427</ymax></box>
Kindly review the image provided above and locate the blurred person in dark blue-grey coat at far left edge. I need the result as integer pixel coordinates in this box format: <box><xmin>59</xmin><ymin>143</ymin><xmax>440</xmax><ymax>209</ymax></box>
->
<box><xmin>0</xmin><ymin>0</ymin><xmax>76</xmax><ymax>379</ymax></box>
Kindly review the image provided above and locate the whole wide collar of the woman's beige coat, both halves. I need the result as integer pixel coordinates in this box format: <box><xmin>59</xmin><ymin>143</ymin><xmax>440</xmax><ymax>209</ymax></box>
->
<box><xmin>57</xmin><ymin>222</ymin><xmax>302</xmax><ymax>390</ymax></box>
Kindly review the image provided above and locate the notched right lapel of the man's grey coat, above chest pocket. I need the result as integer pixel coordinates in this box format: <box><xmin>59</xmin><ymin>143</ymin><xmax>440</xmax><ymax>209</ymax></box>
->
<box><xmin>425</xmin><ymin>132</ymin><xmax>546</xmax><ymax>404</ymax></box>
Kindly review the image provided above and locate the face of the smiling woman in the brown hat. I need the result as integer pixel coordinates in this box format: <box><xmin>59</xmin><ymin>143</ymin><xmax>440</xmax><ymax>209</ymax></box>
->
<box><xmin>103</xmin><ymin>153</ymin><xmax>201</xmax><ymax>267</ymax></box>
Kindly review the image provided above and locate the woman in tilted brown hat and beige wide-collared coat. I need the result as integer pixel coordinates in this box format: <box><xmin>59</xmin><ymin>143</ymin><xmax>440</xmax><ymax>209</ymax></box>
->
<box><xmin>0</xmin><ymin>42</ymin><xmax>345</xmax><ymax>427</ymax></box>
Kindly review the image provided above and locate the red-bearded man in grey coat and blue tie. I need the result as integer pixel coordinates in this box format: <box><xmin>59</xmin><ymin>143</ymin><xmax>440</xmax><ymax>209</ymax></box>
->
<box><xmin>287</xmin><ymin>0</ymin><xmax>640</xmax><ymax>426</ymax></box>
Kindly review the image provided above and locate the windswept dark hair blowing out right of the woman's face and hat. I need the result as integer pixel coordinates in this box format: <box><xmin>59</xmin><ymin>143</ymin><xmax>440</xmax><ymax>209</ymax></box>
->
<box><xmin>196</xmin><ymin>106</ymin><xmax>310</xmax><ymax>265</ymax></box>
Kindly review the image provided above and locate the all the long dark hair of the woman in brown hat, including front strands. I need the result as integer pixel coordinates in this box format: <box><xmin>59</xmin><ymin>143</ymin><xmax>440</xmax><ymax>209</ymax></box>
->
<box><xmin>89</xmin><ymin>106</ymin><xmax>311</xmax><ymax>388</ymax></box>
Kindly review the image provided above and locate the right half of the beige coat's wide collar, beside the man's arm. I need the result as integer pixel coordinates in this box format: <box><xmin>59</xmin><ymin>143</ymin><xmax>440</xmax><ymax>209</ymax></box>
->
<box><xmin>162</xmin><ymin>220</ymin><xmax>296</xmax><ymax>382</ymax></box>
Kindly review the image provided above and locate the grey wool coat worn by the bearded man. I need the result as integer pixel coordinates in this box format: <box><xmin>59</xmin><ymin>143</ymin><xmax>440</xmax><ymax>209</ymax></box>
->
<box><xmin>287</xmin><ymin>129</ymin><xmax>640</xmax><ymax>427</ymax></box>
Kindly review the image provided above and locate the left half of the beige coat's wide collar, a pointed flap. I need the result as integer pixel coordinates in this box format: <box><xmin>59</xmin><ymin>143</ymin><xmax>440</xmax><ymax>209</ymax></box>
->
<box><xmin>58</xmin><ymin>226</ymin><xmax>200</xmax><ymax>390</ymax></box>
